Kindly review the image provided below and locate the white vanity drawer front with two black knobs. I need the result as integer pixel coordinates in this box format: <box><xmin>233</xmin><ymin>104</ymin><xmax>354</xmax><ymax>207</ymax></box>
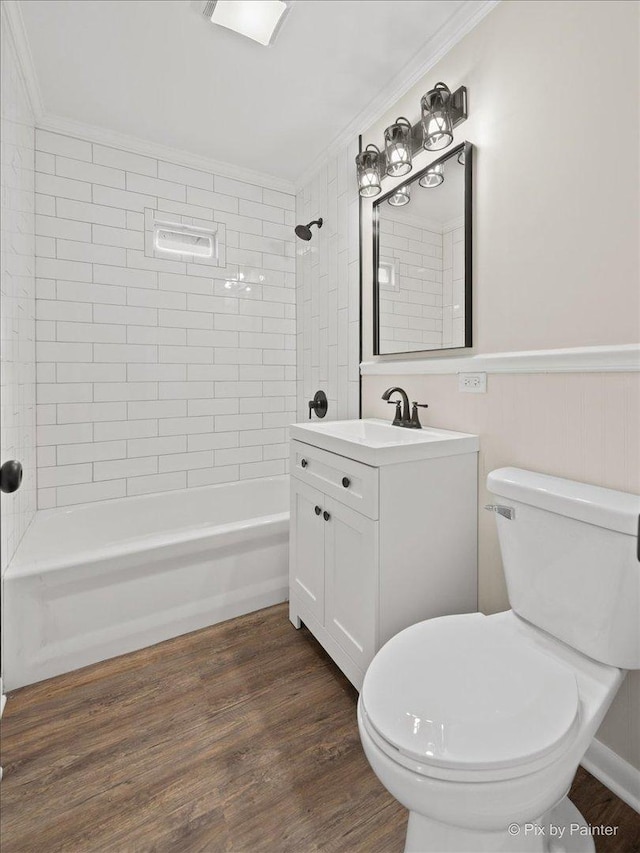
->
<box><xmin>290</xmin><ymin>441</ymin><xmax>378</xmax><ymax>519</ymax></box>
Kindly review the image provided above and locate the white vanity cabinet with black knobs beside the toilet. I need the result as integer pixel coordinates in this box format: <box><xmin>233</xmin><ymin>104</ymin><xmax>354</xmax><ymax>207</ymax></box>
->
<box><xmin>289</xmin><ymin>421</ymin><xmax>478</xmax><ymax>689</ymax></box>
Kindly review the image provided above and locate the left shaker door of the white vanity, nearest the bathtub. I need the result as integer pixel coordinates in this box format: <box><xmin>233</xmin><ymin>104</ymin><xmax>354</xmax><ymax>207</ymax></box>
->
<box><xmin>289</xmin><ymin>477</ymin><xmax>326</xmax><ymax>625</ymax></box>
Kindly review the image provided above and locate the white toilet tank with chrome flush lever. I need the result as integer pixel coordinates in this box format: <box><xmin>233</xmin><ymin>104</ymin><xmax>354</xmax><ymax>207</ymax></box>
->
<box><xmin>487</xmin><ymin>468</ymin><xmax>640</xmax><ymax>669</ymax></box>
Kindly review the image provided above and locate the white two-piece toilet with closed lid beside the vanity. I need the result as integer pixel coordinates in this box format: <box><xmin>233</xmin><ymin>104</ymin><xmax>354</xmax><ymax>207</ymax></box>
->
<box><xmin>358</xmin><ymin>468</ymin><xmax>640</xmax><ymax>853</ymax></box>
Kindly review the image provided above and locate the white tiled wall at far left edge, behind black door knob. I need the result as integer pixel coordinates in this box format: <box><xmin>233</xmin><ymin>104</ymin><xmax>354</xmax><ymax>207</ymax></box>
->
<box><xmin>0</xmin><ymin>6</ymin><xmax>36</xmax><ymax>572</ymax></box>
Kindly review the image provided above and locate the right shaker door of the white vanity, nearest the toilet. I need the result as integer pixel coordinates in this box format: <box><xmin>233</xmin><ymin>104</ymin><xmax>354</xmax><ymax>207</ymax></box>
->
<box><xmin>323</xmin><ymin>499</ymin><xmax>378</xmax><ymax>672</ymax></box>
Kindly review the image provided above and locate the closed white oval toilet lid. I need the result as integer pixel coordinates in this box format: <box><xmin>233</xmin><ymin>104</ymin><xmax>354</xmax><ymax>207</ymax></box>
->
<box><xmin>361</xmin><ymin>613</ymin><xmax>578</xmax><ymax>770</ymax></box>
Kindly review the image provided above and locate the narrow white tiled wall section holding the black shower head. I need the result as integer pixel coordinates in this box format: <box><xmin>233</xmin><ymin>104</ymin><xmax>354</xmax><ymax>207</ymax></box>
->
<box><xmin>296</xmin><ymin>143</ymin><xmax>360</xmax><ymax>420</ymax></box>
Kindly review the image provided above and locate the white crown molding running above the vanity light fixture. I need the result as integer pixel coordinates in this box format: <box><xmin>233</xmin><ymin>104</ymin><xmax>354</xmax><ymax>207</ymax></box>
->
<box><xmin>295</xmin><ymin>0</ymin><xmax>500</xmax><ymax>190</ymax></box>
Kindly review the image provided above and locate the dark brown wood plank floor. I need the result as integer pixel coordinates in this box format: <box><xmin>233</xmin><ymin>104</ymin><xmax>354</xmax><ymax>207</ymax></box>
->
<box><xmin>0</xmin><ymin>605</ymin><xmax>640</xmax><ymax>853</ymax></box>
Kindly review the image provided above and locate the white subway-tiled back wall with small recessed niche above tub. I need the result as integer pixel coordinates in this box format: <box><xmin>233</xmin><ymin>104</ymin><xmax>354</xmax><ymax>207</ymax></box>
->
<box><xmin>36</xmin><ymin>130</ymin><xmax>296</xmax><ymax>509</ymax></box>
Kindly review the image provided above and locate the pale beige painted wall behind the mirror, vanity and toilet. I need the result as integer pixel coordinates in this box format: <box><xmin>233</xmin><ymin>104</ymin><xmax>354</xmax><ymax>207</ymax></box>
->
<box><xmin>360</xmin><ymin>0</ymin><xmax>640</xmax><ymax>767</ymax></box>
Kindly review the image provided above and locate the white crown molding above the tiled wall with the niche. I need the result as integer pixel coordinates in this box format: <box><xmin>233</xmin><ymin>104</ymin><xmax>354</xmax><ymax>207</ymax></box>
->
<box><xmin>36</xmin><ymin>113</ymin><xmax>295</xmax><ymax>194</ymax></box>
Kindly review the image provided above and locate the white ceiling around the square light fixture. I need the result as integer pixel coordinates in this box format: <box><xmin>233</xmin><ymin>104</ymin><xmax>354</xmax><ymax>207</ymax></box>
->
<box><xmin>20</xmin><ymin>0</ymin><xmax>477</xmax><ymax>181</ymax></box>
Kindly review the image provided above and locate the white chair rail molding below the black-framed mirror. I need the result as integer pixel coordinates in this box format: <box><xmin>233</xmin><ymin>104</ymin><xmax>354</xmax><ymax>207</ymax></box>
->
<box><xmin>360</xmin><ymin>344</ymin><xmax>640</xmax><ymax>376</ymax></box>
